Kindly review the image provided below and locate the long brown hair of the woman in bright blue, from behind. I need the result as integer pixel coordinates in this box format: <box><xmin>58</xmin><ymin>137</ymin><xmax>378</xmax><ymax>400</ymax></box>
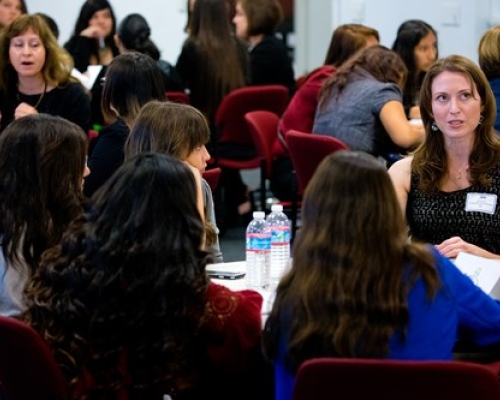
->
<box><xmin>263</xmin><ymin>151</ymin><xmax>440</xmax><ymax>371</ymax></box>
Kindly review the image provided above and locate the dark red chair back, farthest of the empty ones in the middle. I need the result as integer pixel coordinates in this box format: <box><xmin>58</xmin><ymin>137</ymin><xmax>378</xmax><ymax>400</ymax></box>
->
<box><xmin>215</xmin><ymin>85</ymin><xmax>289</xmax><ymax>145</ymax></box>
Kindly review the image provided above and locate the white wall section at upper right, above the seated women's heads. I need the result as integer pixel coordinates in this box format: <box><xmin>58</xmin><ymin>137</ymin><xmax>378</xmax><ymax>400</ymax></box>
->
<box><xmin>295</xmin><ymin>0</ymin><xmax>500</xmax><ymax>74</ymax></box>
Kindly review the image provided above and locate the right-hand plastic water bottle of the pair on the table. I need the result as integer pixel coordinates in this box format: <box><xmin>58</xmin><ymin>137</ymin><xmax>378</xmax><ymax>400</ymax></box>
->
<box><xmin>267</xmin><ymin>204</ymin><xmax>291</xmax><ymax>289</ymax></box>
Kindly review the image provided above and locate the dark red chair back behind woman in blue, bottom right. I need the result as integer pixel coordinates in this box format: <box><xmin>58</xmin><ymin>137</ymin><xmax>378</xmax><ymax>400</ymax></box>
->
<box><xmin>293</xmin><ymin>358</ymin><xmax>500</xmax><ymax>400</ymax></box>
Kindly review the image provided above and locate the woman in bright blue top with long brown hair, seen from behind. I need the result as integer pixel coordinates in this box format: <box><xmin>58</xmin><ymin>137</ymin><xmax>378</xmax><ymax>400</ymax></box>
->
<box><xmin>264</xmin><ymin>151</ymin><xmax>500</xmax><ymax>400</ymax></box>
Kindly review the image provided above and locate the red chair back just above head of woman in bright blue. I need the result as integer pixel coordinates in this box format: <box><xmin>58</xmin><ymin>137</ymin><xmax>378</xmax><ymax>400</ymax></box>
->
<box><xmin>286</xmin><ymin>129</ymin><xmax>349</xmax><ymax>195</ymax></box>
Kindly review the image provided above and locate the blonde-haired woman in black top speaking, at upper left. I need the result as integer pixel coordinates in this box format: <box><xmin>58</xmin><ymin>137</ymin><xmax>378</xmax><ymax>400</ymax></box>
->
<box><xmin>0</xmin><ymin>14</ymin><xmax>91</xmax><ymax>132</ymax></box>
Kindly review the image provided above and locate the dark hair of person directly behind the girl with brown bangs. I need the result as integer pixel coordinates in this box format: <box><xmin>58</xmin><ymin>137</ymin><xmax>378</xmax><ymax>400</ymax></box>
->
<box><xmin>101</xmin><ymin>53</ymin><xmax>165</xmax><ymax>126</ymax></box>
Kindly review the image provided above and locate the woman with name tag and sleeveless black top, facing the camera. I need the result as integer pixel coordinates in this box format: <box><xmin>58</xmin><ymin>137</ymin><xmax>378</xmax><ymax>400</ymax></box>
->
<box><xmin>389</xmin><ymin>55</ymin><xmax>500</xmax><ymax>258</ymax></box>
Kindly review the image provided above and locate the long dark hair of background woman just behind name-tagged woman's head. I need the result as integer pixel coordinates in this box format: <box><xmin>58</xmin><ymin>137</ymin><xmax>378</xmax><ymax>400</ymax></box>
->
<box><xmin>392</xmin><ymin>19</ymin><xmax>438</xmax><ymax>105</ymax></box>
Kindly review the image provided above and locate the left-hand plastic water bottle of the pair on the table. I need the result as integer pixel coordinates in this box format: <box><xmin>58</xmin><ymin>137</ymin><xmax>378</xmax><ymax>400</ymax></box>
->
<box><xmin>246</xmin><ymin>211</ymin><xmax>271</xmax><ymax>289</ymax></box>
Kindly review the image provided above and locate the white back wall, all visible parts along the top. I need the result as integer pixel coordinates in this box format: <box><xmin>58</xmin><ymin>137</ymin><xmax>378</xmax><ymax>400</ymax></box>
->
<box><xmin>26</xmin><ymin>0</ymin><xmax>500</xmax><ymax>75</ymax></box>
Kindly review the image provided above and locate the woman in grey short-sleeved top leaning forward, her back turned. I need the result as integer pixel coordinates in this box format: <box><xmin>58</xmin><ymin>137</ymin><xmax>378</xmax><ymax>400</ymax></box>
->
<box><xmin>313</xmin><ymin>45</ymin><xmax>425</xmax><ymax>166</ymax></box>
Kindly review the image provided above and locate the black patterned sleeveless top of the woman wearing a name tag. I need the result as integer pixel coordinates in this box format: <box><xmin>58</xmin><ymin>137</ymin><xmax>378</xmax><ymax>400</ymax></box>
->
<box><xmin>406</xmin><ymin>163</ymin><xmax>500</xmax><ymax>254</ymax></box>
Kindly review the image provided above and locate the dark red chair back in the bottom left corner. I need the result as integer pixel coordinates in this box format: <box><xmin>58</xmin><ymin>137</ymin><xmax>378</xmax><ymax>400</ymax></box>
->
<box><xmin>0</xmin><ymin>316</ymin><xmax>67</xmax><ymax>400</ymax></box>
